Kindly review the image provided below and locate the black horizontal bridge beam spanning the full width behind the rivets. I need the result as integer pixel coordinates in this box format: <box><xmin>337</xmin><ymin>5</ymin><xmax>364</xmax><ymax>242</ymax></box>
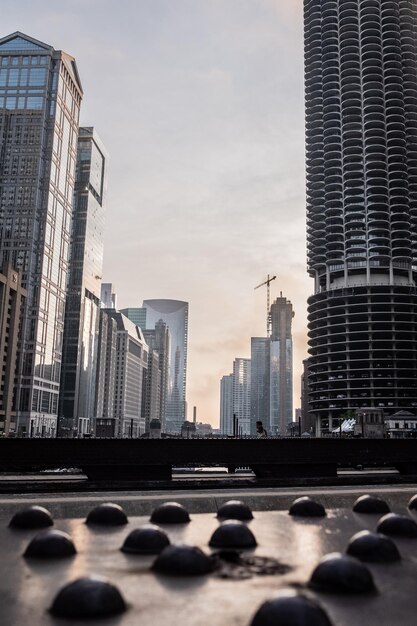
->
<box><xmin>0</xmin><ymin>438</ymin><xmax>417</xmax><ymax>481</ymax></box>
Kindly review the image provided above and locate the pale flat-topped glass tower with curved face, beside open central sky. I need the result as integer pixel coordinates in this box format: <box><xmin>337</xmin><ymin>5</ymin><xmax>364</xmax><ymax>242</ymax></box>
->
<box><xmin>143</xmin><ymin>300</ymin><xmax>188</xmax><ymax>433</ymax></box>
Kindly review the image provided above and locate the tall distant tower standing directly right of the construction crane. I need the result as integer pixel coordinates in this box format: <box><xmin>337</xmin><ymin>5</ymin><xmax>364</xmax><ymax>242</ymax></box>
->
<box><xmin>269</xmin><ymin>294</ymin><xmax>294</xmax><ymax>437</ymax></box>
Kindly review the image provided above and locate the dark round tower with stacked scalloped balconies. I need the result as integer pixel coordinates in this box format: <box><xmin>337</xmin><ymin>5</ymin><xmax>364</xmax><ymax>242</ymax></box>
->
<box><xmin>304</xmin><ymin>0</ymin><xmax>417</xmax><ymax>430</ymax></box>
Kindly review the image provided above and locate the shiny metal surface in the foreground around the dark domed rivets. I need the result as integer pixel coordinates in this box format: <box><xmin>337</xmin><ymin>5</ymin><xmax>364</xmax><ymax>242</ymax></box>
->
<box><xmin>0</xmin><ymin>502</ymin><xmax>417</xmax><ymax>626</ymax></box>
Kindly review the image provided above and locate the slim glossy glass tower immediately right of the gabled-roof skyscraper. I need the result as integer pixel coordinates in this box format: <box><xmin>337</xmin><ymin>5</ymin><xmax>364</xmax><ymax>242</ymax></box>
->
<box><xmin>58</xmin><ymin>128</ymin><xmax>107</xmax><ymax>436</ymax></box>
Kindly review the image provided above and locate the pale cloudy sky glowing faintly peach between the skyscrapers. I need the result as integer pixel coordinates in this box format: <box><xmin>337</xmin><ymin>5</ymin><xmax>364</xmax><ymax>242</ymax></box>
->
<box><xmin>0</xmin><ymin>0</ymin><xmax>313</xmax><ymax>426</ymax></box>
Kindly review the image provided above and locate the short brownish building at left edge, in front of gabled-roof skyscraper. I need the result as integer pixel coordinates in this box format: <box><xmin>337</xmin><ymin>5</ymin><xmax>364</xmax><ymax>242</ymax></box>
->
<box><xmin>0</xmin><ymin>263</ymin><xmax>27</xmax><ymax>437</ymax></box>
